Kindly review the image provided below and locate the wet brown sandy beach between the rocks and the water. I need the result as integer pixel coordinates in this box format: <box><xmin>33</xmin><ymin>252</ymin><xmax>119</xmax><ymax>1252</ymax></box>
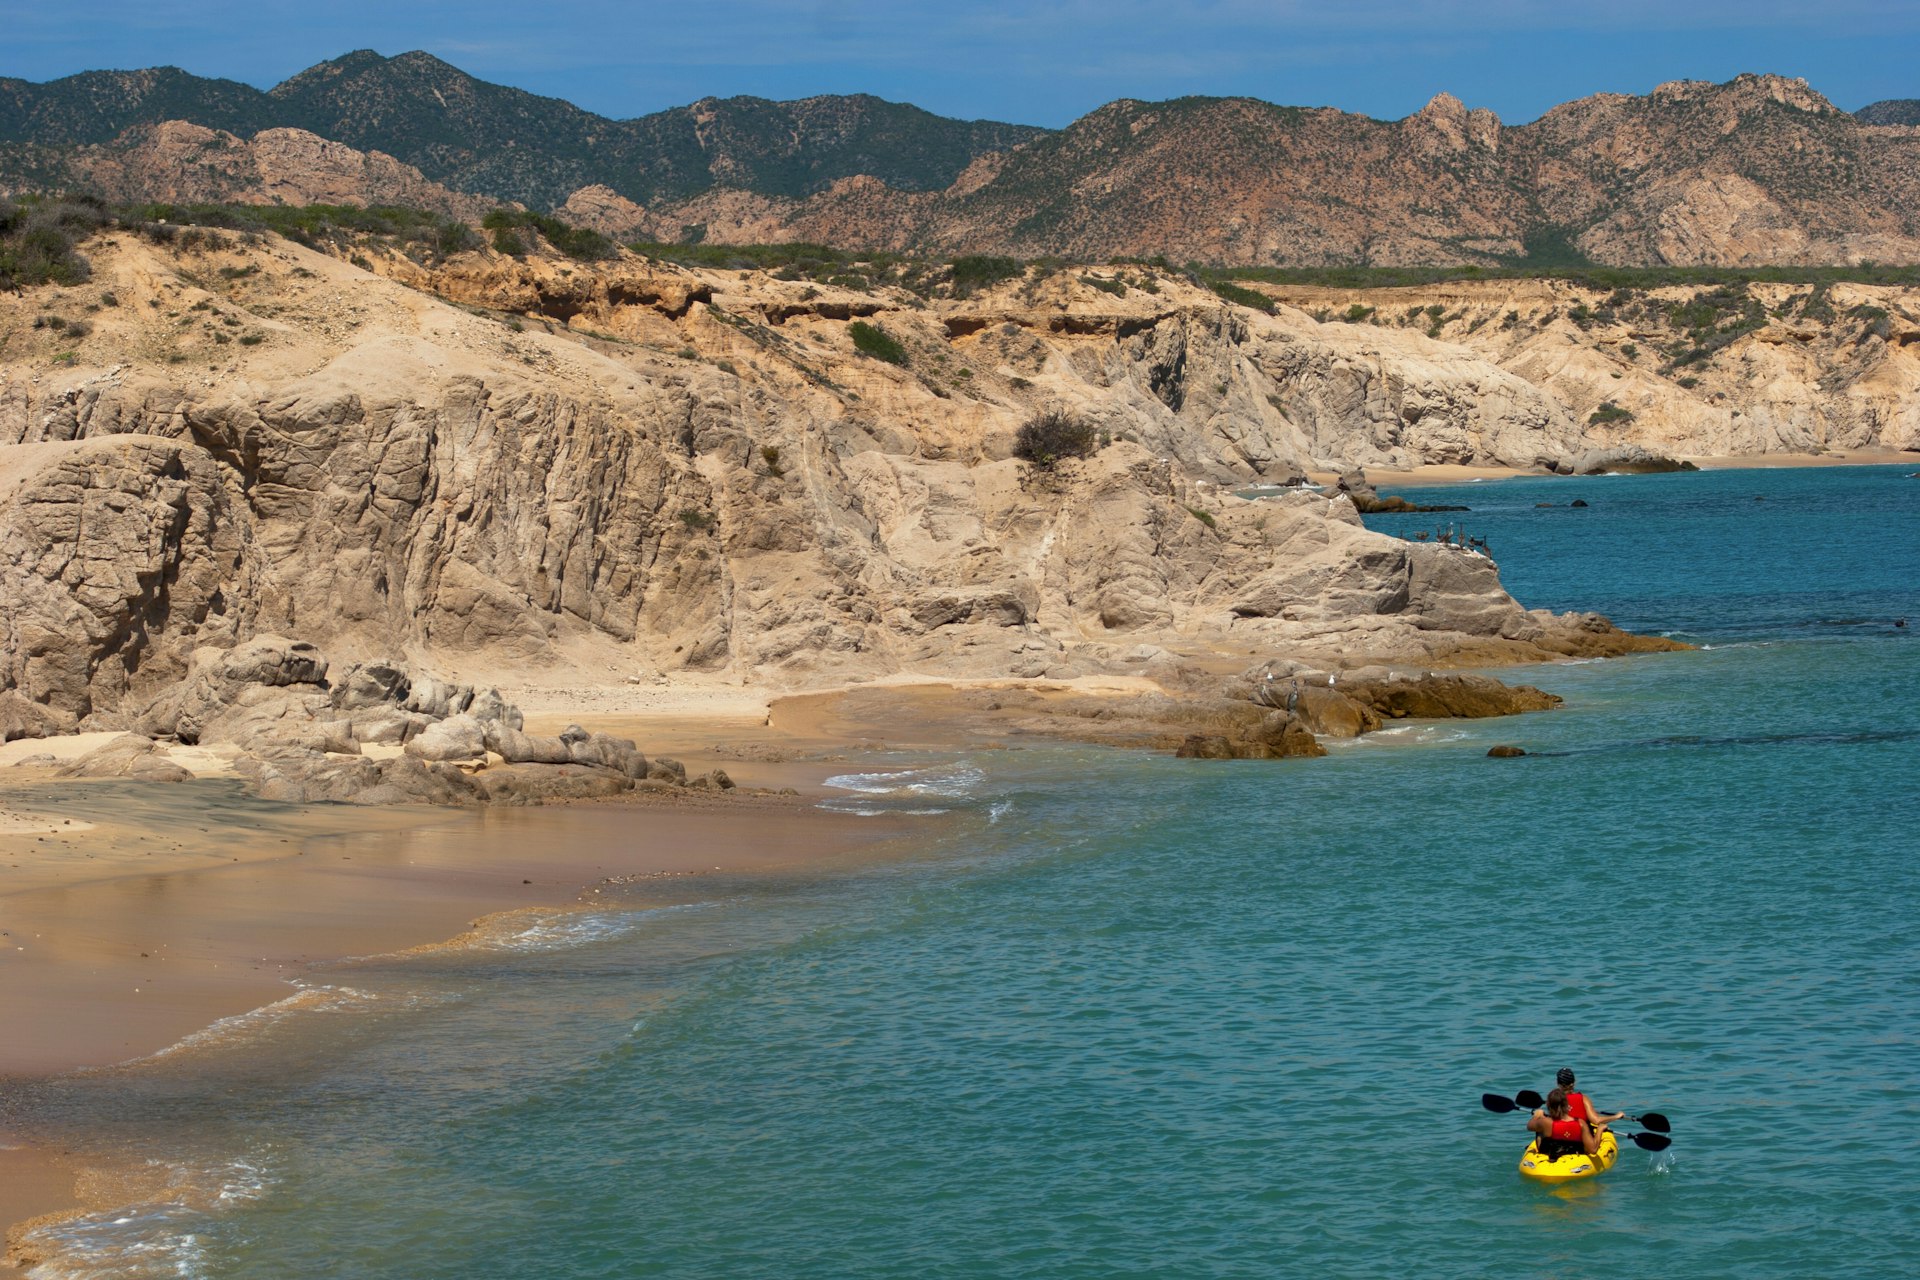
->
<box><xmin>0</xmin><ymin>702</ymin><xmax>933</xmax><ymax>1274</ymax></box>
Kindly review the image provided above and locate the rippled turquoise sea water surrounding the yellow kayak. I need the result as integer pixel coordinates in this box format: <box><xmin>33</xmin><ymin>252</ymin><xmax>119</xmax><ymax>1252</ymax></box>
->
<box><xmin>15</xmin><ymin>468</ymin><xmax>1920</xmax><ymax>1280</ymax></box>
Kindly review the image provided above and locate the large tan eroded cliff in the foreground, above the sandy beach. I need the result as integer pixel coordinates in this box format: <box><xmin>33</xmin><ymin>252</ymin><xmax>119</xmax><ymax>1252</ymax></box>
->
<box><xmin>0</xmin><ymin>234</ymin><xmax>1697</xmax><ymax>725</ymax></box>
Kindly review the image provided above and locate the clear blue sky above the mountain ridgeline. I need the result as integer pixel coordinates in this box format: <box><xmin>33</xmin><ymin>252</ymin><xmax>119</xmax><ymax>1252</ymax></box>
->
<box><xmin>0</xmin><ymin>0</ymin><xmax>1920</xmax><ymax>127</ymax></box>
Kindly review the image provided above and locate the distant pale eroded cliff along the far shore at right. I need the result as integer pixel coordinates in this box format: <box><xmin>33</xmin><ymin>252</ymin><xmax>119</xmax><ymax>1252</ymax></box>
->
<box><xmin>1256</xmin><ymin>280</ymin><xmax>1920</xmax><ymax>461</ymax></box>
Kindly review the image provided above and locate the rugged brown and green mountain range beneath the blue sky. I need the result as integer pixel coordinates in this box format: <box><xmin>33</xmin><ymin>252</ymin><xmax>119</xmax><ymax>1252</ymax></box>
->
<box><xmin>0</xmin><ymin>50</ymin><xmax>1920</xmax><ymax>265</ymax></box>
